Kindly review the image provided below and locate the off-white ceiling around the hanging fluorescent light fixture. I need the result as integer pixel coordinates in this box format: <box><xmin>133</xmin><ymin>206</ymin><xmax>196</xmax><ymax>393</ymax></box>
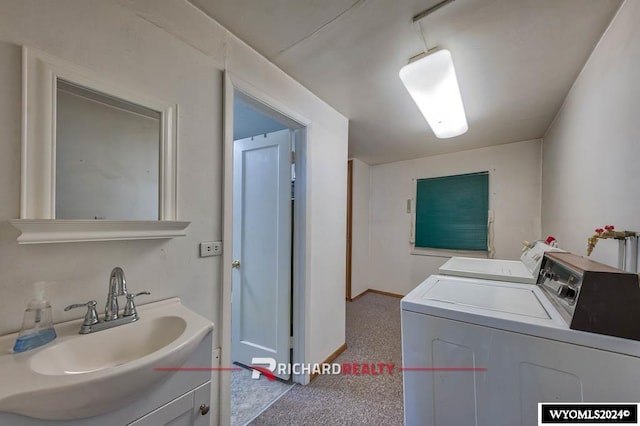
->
<box><xmin>190</xmin><ymin>0</ymin><xmax>621</xmax><ymax>165</ymax></box>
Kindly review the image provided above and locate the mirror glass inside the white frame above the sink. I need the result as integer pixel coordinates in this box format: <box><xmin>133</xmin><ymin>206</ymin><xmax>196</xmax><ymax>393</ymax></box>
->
<box><xmin>55</xmin><ymin>79</ymin><xmax>162</xmax><ymax>220</ymax></box>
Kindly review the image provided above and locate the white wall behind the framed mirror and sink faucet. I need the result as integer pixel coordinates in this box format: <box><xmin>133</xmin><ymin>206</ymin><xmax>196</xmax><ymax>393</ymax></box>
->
<box><xmin>0</xmin><ymin>0</ymin><xmax>222</xmax><ymax>341</ymax></box>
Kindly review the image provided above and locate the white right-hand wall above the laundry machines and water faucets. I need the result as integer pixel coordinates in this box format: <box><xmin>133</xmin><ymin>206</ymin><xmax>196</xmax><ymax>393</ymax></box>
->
<box><xmin>542</xmin><ymin>1</ymin><xmax>640</xmax><ymax>266</ymax></box>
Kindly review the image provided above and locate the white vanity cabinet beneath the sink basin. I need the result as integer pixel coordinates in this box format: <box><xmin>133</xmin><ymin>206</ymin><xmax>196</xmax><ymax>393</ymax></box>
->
<box><xmin>0</xmin><ymin>332</ymin><xmax>217</xmax><ymax>426</ymax></box>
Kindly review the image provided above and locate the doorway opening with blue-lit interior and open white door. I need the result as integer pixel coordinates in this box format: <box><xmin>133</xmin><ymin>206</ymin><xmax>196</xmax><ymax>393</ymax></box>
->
<box><xmin>220</xmin><ymin>76</ymin><xmax>306</xmax><ymax>424</ymax></box>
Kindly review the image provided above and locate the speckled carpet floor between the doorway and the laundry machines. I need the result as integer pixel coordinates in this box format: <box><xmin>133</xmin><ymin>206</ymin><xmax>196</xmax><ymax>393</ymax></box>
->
<box><xmin>250</xmin><ymin>293</ymin><xmax>404</xmax><ymax>426</ymax></box>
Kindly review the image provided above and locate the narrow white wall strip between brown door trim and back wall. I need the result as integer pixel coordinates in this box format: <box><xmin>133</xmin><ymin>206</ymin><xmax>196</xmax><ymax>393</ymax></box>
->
<box><xmin>351</xmin><ymin>158</ymin><xmax>371</xmax><ymax>297</ymax></box>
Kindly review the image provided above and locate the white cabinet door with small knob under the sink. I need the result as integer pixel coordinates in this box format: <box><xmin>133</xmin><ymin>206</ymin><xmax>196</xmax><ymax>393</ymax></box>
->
<box><xmin>129</xmin><ymin>383</ymin><xmax>211</xmax><ymax>426</ymax></box>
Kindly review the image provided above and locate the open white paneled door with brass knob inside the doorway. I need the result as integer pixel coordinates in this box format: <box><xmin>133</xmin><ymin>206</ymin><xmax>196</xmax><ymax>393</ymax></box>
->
<box><xmin>231</xmin><ymin>129</ymin><xmax>291</xmax><ymax>380</ymax></box>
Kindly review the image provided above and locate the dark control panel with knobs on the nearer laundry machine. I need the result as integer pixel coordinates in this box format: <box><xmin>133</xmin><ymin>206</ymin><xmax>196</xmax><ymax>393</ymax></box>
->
<box><xmin>537</xmin><ymin>252</ymin><xmax>640</xmax><ymax>340</ymax></box>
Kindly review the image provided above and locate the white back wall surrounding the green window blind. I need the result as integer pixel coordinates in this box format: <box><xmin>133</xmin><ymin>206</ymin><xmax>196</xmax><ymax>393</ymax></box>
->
<box><xmin>368</xmin><ymin>140</ymin><xmax>541</xmax><ymax>294</ymax></box>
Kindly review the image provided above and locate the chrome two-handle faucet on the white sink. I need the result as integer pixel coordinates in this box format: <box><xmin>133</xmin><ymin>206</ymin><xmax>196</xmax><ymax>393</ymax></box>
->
<box><xmin>64</xmin><ymin>266</ymin><xmax>151</xmax><ymax>334</ymax></box>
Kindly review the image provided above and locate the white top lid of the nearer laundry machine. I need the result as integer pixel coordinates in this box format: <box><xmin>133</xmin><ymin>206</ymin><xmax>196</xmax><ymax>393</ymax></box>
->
<box><xmin>420</xmin><ymin>279</ymin><xmax>551</xmax><ymax>319</ymax></box>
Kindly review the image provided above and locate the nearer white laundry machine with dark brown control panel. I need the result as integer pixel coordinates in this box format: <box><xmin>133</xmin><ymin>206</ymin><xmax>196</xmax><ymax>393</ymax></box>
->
<box><xmin>401</xmin><ymin>253</ymin><xmax>640</xmax><ymax>426</ymax></box>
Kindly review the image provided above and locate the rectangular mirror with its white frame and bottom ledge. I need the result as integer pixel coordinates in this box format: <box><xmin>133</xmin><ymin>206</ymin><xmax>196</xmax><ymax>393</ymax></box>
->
<box><xmin>10</xmin><ymin>47</ymin><xmax>189</xmax><ymax>243</ymax></box>
